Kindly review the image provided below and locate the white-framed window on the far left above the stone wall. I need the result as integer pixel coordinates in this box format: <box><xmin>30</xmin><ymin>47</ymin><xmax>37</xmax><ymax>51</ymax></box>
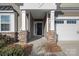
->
<box><xmin>1</xmin><ymin>15</ymin><xmax>10</xmax><ymax>31</ymax></box>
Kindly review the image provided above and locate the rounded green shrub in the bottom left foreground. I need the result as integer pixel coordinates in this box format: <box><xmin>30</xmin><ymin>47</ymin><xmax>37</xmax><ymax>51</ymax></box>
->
<box><xmin>0</xmin><ymin>45</ymin><xmax>24</xmax><ymax>56</ymax></box>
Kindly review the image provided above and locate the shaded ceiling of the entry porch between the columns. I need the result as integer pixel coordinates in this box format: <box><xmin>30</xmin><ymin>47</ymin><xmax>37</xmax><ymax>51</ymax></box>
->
<box><xmin>31</xmin><ymin>10</ymin><xmax>48</xmax><ymax>19</ymax></box>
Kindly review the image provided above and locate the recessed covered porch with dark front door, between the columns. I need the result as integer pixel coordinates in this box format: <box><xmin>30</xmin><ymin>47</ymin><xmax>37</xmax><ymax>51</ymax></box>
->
<box><xmin>26</xmin><ymin>10</ymin><xmax>49</xmax><ymax>42</ymax></box>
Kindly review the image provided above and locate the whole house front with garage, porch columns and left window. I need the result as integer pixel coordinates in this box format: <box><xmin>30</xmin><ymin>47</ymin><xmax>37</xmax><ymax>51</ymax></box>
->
<box><xmin>0</xmin><ymin>3</ymin><xmax>79</xmax><ymax>42</ymax></box>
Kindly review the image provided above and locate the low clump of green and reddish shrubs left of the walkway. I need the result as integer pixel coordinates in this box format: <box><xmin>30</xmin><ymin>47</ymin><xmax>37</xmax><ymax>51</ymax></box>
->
<box><xmin>0</xmin><ymin>44</ymin><xmax>33</xmax><ymax>56</ymax></box>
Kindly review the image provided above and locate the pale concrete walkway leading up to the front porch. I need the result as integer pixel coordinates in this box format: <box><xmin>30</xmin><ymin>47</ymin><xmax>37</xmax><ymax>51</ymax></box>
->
<box><xmin>28</xmin><ymin>37</ymin><xmax>65</xmax><ymax>56</ymax></box>
